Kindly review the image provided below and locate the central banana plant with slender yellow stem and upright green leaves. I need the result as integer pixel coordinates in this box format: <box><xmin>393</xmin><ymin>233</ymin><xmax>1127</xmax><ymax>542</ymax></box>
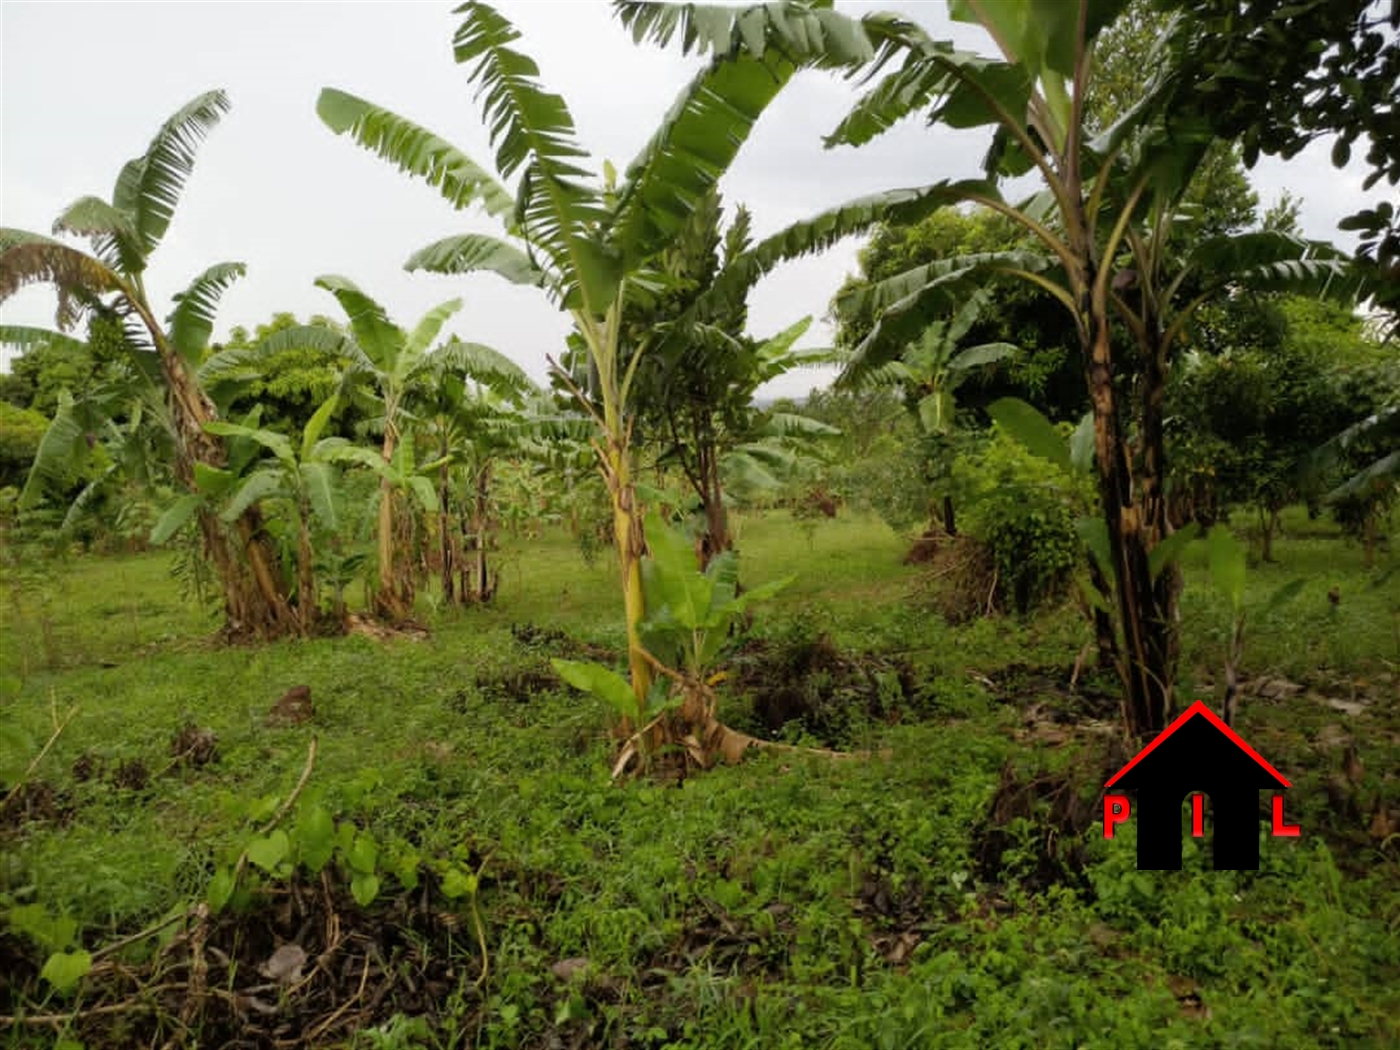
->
<box><xmin>318</xmin><ymin>0</ymin><xmax>872</xmax><ymax>733</ymax></box>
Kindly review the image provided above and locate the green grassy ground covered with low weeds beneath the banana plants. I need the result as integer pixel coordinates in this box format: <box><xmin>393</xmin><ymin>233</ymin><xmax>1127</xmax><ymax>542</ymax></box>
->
<box><xmin>0</xmin><ymin>514</ymin><xmax>1400</xmax><ymax>1049</ymax></box>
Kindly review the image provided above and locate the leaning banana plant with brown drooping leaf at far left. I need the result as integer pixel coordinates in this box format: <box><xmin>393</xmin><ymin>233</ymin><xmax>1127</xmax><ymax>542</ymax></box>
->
<box><xmin>0</xmin><ymin>91</ymin><xmax>297</xmax><ymax>637</ymax></box>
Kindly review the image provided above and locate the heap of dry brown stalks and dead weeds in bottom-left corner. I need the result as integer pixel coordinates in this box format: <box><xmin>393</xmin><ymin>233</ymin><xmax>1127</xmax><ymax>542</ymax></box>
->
<box><xmin>0</xmin><ymin>878</ymin><xmax>482</xmax><ymax>1047</ymax></box>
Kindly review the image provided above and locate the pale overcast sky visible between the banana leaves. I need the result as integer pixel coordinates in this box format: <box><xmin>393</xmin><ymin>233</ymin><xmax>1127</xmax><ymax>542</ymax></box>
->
<box><xmin>0</xmin><ymin>0</ymin><xmax>1364</xmax><ymax>395</ymax></box>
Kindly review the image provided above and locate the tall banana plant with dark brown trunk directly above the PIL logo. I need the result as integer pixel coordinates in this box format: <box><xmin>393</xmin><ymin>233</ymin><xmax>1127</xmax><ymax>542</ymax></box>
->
<box><xmin>827</xmin><ymin>0</ymin><xmax>1351</xmax><ymax>736</ymax></box>
